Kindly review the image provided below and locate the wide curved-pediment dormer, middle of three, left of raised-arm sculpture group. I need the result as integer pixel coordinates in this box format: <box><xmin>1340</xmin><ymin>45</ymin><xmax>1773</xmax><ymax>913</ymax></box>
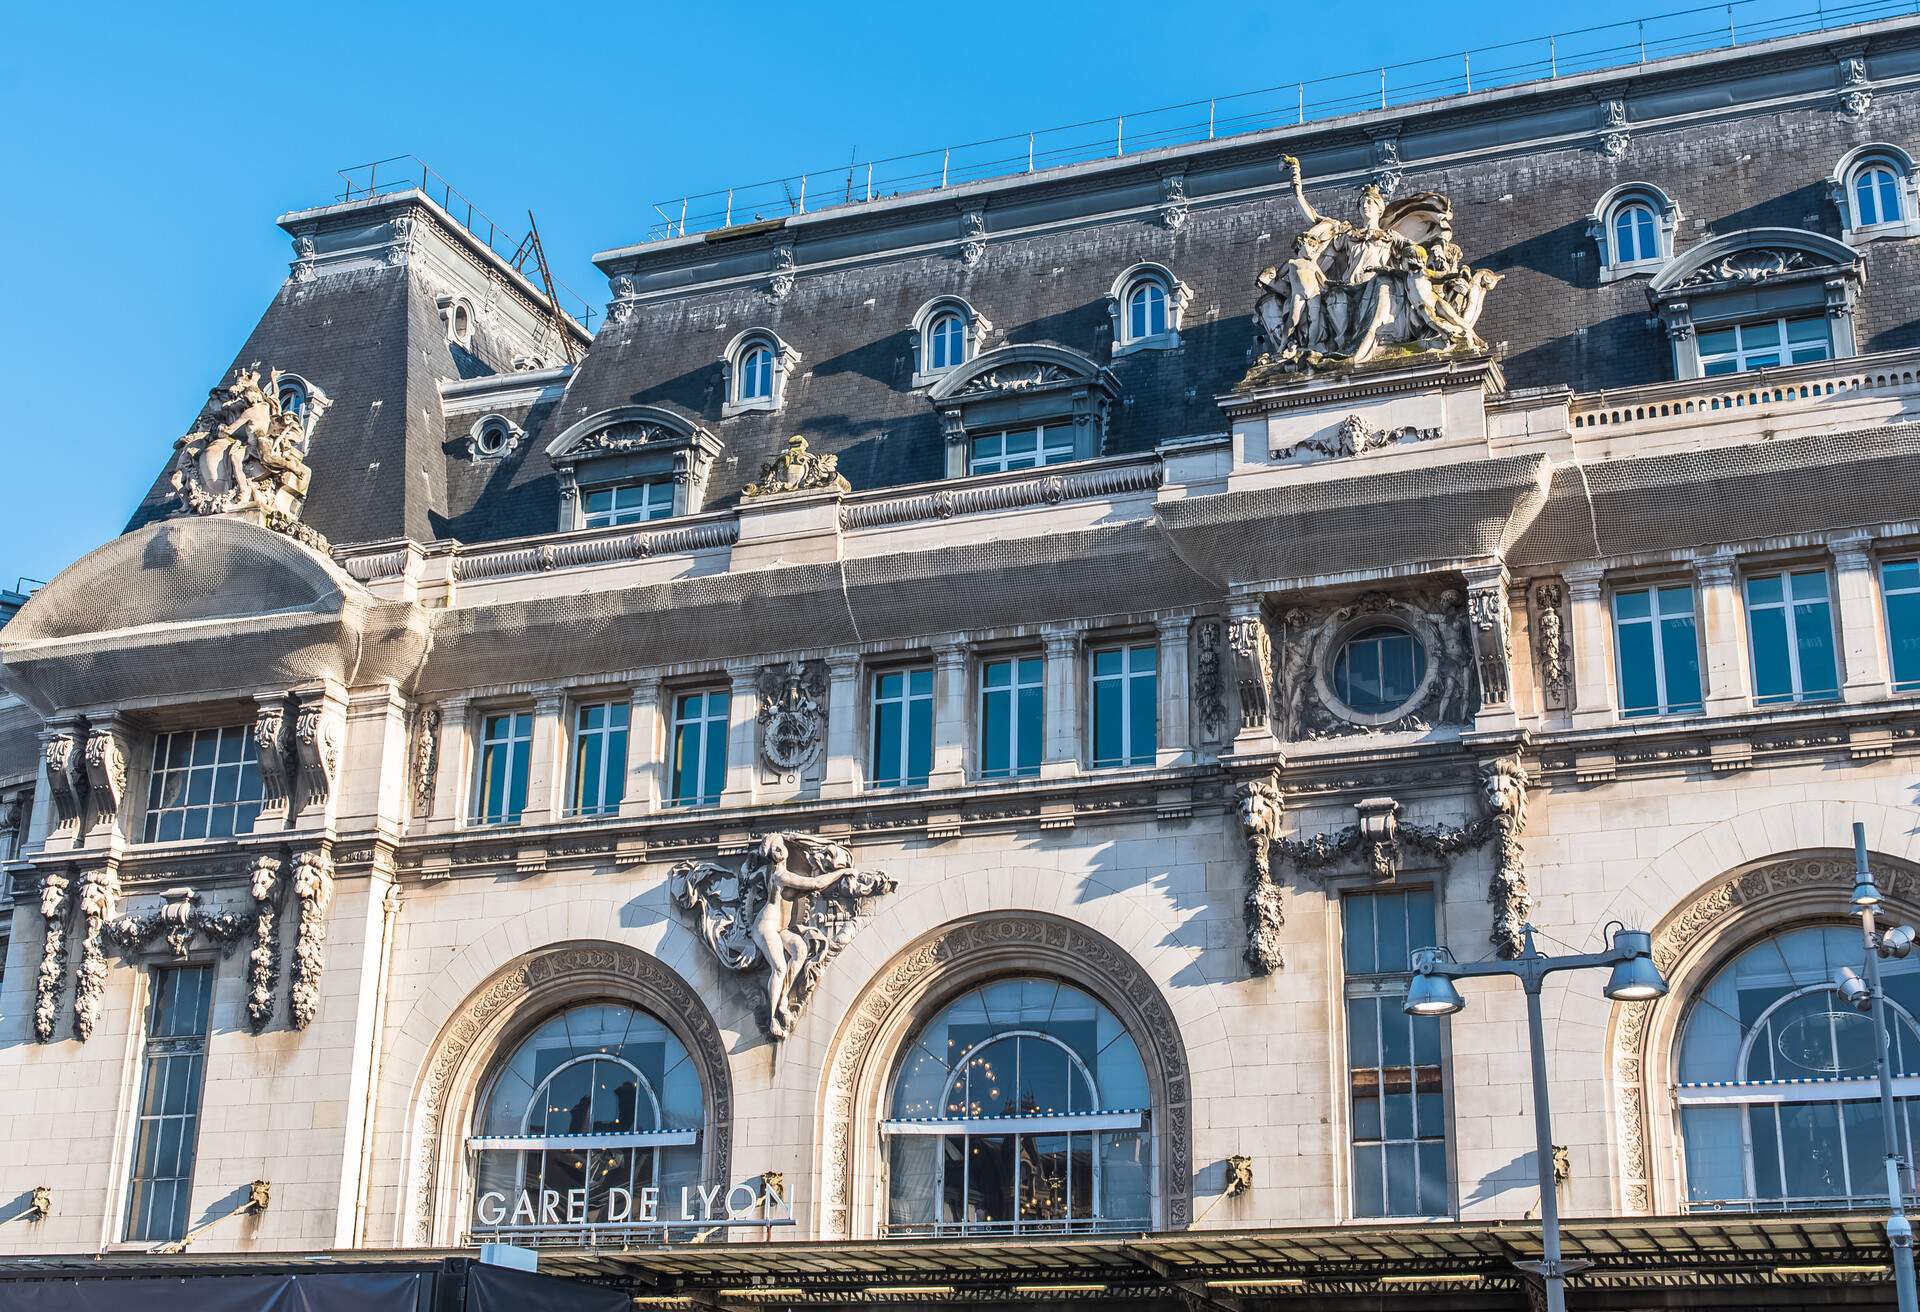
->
<box><xmin>927</xmin><ymin>344</ymin><xmax>1119</xmax><ymax>478</ymax></box>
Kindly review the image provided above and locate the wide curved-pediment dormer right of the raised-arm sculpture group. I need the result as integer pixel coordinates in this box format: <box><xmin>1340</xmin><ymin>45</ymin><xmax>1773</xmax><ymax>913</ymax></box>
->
<box><xmin>1647</xmin><ymin>229</ymin><xmax>1866</xmax><ymax>378</ymax></box>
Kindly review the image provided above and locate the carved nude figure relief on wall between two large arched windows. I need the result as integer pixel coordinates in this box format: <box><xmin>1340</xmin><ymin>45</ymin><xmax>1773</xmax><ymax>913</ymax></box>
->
<box><xmin>672</xmin><ymin>834</ymin><xmax>895</xmax><ymax>1039</ymax></box>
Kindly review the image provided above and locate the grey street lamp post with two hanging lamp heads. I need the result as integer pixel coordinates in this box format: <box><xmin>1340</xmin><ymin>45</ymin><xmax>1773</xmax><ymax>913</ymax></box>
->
<box><xmin>1404</xmin><ymin>924</ymin><xmax>1667</xmax><ymax>1312</ymax></box>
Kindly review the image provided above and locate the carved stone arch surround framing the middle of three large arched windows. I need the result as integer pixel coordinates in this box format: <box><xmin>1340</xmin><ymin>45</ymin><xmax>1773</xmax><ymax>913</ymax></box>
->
<box><xmin>822</xmin><ymin>914</ymin><xmax>1192</xmax><ymax>1237</ymax></box>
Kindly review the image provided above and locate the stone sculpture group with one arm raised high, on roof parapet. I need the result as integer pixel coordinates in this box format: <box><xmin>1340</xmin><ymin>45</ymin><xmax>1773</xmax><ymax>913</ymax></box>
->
<box><xmin>1254</xmin><ymin>156</ymin><xmax>1501</xmax><ymax>369</ymax></box>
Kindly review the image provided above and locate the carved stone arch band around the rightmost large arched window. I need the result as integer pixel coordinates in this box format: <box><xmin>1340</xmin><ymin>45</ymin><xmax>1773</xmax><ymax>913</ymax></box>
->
<box><xmin>1613</xmin><ymin>855</ymin><xmax>1920</xmax><ymax>1212</ymax></box>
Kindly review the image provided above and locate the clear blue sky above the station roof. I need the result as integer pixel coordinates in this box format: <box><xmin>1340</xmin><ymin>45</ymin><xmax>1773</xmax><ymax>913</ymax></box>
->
<box><xmin>0</xmin><ymin>0</ymin><xmax>1835</xmax><ymax>586</ymax></box>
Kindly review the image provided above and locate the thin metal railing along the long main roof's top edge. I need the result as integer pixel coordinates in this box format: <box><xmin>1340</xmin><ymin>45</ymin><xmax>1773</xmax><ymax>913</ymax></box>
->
<box><xmin>647</xmin><ymin>0</ymin><xmax>1920</xmax><ymax>240</ymax></box>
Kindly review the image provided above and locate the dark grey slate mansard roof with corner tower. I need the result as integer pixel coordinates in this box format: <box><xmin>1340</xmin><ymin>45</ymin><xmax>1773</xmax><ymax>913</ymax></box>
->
<box><xmin>123</xmin><ymin>19</ymin><xmax>1920</xmax><ymax>546</ymax></box>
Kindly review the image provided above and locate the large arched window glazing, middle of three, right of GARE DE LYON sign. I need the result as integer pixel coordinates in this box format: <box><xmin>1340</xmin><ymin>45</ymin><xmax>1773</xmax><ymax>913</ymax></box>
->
<box><xmin>881</xmin><ymin>978</ymin><xmax>1152</xmax><ymax>1235</ymax></box>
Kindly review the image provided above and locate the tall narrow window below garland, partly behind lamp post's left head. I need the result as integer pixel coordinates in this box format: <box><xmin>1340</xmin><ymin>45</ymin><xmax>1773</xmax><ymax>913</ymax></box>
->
<box><xmin>1340</xmin><ymin>889</ymin><xmax>1452</xmax><ymax>1216</ymax></box>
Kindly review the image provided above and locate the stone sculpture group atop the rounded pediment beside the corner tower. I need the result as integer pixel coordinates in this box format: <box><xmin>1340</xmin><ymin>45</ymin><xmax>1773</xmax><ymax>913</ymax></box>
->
<box><xmin>171</xmin><ymin>365</ymin><xmax>309</xmax><ymax>522</ymax></box>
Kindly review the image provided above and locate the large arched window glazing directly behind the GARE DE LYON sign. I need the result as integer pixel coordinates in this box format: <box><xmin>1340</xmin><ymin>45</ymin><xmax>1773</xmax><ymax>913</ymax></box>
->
<box><xmin>467</xmin><ymin>1003</ymin><xmax>705</xmax><ymax>1233</ymax></box>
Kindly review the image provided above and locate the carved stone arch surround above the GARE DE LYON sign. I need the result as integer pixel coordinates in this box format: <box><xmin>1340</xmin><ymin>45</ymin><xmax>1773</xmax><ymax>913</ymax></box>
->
<box><xmin>413</xmin><ymin>943</ymin><xmax>733</xmax><ymax>1243</ymax></box>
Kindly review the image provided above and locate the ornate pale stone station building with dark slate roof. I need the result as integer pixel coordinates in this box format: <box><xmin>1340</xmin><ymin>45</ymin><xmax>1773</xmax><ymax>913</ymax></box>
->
<box><xmin>11</xmin><ymin>19</ymin><xmax>1920</xmax><ymax>1308</ymax></box>
